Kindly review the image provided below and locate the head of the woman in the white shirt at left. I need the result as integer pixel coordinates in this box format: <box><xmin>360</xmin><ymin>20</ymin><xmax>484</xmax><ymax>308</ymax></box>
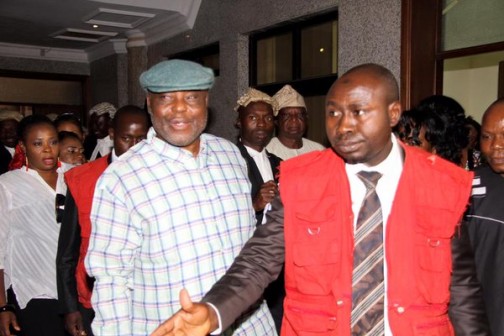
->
<box><xmin>21</xmin><ymin>124</ymin><xmax>59</xmax><ymax>173</ymax></box>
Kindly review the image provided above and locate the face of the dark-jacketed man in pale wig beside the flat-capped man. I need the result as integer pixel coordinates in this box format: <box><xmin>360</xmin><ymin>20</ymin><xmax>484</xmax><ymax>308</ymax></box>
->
<box><xmin>236</xmin><ymin>101</ymin><xmax>275</xmax><ymax>152</ymax></box>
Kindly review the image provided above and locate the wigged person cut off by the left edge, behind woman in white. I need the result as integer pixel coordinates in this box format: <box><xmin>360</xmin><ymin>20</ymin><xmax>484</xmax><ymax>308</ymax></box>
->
<box><xmin>0</xmin><ymin>111</ymin><xmax>23</xmax><ymax>175</ymax></box>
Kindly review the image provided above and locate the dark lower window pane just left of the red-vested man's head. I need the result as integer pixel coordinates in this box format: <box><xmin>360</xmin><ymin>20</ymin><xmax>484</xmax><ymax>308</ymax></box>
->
<box><xmin>304</xmin><ymin>95</ymin><xmax>328</xmax><ymax>147</ymax></box>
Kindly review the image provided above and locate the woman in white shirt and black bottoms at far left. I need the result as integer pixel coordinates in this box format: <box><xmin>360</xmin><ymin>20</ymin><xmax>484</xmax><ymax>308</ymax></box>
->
<box><xmin>0</xmin><ymin>115</ymin><xmax>66</xmax><ymax>336</ymax></box>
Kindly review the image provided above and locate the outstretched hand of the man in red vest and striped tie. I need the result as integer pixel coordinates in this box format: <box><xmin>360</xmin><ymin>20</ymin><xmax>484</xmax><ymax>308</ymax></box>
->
<box><xmin>150</xmin><ymin>289</ymin><xmax>219</xmax><ymax>336</ymax></box>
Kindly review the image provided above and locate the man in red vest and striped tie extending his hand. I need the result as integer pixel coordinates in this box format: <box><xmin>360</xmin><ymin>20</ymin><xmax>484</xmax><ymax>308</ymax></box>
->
<box><xmin>152</xmin><ymin>64</ymin><xmax>488</xmax><ymax>336</ymax></box>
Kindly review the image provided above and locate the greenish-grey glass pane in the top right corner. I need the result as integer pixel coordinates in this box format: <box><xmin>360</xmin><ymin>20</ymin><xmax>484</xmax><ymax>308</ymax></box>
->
<box><xmin>441</xmin><ymin>0</ymin><xmax>504</xmax><ymax>50</ymax></box>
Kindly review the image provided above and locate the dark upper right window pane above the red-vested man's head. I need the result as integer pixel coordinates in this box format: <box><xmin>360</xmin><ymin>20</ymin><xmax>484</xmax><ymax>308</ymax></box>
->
<box><xmin>301</xmin><ymin>20</ymin><xmax>338</xmax><ymax>78</ymax></box>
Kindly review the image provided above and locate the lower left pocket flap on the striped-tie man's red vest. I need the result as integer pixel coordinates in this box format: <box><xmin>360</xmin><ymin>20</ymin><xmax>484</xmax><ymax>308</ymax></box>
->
<box><xmin>293</xmin><ymin>241</ymin><xmax>341</xmax><ymax>266</ymax></box>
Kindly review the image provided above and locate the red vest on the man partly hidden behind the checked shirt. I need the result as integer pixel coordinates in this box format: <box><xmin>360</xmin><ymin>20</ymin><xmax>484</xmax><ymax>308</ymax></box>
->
<box><xmin>65</xmin><ymin>155</ymin><xmax>109</xmax><ymax>308</ymax></box>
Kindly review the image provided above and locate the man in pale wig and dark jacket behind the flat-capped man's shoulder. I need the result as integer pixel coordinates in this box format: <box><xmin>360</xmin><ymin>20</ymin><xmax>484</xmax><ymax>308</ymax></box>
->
<box><xmin>235</xmin><ymin>88</ymin><xmax>285</xmax><ymax>334</ymax></box>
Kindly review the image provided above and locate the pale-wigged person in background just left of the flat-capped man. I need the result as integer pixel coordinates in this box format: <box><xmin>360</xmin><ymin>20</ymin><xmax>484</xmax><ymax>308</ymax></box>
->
<box><xmin>84</xmin><ymin>102</ymin><xmax>116</xmax><ymax>161</ymax></box>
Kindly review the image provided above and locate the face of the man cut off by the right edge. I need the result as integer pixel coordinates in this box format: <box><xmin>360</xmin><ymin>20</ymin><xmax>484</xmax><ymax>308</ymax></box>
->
<box><xmin>480</xmin><ymin>100</ymin><xmax>504</xmax><ymax>177</ymax></box>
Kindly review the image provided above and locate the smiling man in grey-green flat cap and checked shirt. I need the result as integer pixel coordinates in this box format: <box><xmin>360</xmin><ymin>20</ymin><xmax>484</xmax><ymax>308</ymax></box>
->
<box><xmin>85</xmin><ymin>60</ymin><xmax>276</xmax><ymax>336</ymax></box>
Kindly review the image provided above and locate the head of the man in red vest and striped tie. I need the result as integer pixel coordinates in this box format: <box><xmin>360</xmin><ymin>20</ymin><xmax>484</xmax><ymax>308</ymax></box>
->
<box><xmin>326</xmin><ymin>70</ymin><xmax>401</xmax><ymax>166</ymax></box>
